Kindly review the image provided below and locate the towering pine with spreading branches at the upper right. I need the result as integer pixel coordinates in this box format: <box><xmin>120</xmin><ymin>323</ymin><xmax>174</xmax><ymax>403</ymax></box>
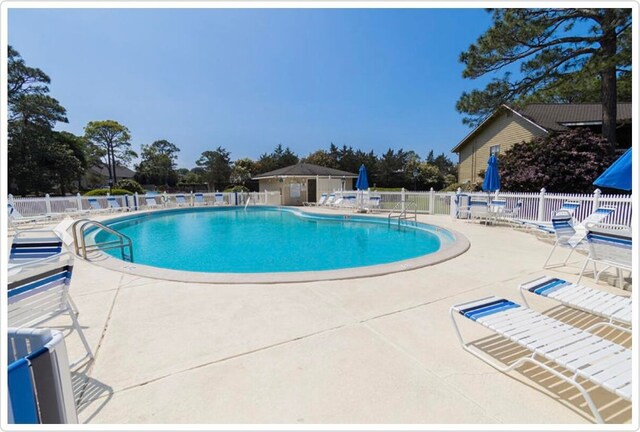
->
<box><xmin>456</xmin><ymin>8</ymin><xmax>631</xmax><ymax>143</ymax></box>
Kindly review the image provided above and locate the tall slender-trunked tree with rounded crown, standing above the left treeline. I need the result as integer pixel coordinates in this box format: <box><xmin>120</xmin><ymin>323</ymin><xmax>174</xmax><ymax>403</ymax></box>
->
<box><xmin>84</xmin><ymin>120</ymin><xmax>137</xmax><ymax>185</ymax></box>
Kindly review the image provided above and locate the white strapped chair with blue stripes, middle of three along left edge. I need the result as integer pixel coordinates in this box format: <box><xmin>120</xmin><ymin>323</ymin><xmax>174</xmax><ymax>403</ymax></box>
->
<box><xmin>7</xmin><ymin>253</ymin><xmax>93</xmax><ymax>366</ymax></box>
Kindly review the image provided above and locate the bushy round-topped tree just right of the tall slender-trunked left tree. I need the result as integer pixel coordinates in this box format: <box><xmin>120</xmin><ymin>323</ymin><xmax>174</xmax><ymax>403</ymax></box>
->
<box><xmin>135</xmin><ymin>140</ymin><xmax>180</xmax><ymax>186</ymax></box>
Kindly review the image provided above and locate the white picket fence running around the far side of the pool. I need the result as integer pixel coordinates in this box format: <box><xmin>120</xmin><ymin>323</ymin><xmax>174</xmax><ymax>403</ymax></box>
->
<box><xmin>9</xmin><ymin>189</ymin><xmax>632</xmax><ymax>226</ymax></box>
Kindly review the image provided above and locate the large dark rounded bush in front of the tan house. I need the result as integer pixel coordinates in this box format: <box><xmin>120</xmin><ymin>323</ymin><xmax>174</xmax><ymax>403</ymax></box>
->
<box><xmin>499</xmin><ymin>129</ymin><xmax>618</xmax><ymax>193</ymax></box>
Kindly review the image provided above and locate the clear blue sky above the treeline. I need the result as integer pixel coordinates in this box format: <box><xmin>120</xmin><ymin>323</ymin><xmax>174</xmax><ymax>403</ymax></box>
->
<box><xmin>8</xmin><ymin>9</ymin><xmax>490</xmax><ymax>168</ymax></box>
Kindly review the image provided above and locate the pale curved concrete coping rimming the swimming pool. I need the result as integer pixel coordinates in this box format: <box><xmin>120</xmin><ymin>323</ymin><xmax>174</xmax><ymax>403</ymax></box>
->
<box><xmin>80</xmin><ymin>206</ymin><xmax>471</xmax><ymax>284</ymax></box>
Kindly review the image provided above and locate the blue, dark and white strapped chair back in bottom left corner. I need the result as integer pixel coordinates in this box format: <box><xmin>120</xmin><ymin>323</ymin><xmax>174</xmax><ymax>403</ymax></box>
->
<box><xmin>7</xmin><ymin>328</ymin><xmax>78</xmax><ymax>424</ymax></box>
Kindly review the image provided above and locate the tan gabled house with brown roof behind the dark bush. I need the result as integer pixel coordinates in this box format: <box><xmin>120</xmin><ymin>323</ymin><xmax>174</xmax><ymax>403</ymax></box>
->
<box><xmin>451</xmin><ymin>103</ymin><xmax>631</xmax><ymax>183</ymax></box>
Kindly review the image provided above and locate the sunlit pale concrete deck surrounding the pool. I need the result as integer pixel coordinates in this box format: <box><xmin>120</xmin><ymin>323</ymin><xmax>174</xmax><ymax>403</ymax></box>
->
<box><xmin>12</xmin><ymin>209</ymin><xmax>631</xmax><ymax>425</ymax></box>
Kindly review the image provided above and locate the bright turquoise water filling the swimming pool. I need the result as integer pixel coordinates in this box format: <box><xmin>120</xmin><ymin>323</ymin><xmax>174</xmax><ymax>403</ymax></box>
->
<box><xmin>95</xmin><ymin>207</ymin><xmax>453</xmax><ymax>273</ymax></box>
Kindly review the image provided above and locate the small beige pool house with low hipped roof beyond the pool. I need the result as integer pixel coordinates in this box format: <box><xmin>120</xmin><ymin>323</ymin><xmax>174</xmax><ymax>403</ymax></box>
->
<box><xmin>252</xmin><ymin>163</ymin><xmax>358</xmax><ymax>205</ymax></box>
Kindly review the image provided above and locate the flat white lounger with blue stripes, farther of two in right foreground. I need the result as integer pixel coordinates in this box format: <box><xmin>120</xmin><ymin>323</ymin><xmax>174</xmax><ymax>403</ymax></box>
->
<box><xmin>519</xmin><ymin>276</ymin><xmax>631</xmax><ymax>332</ymax></box>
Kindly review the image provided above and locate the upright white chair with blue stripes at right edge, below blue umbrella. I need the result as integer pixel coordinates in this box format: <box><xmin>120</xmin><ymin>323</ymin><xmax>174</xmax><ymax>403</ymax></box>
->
<box><xmin>578</xmin><ymin>222</ymin><xmax>633</xmax><ymax>288</ymax></box>
